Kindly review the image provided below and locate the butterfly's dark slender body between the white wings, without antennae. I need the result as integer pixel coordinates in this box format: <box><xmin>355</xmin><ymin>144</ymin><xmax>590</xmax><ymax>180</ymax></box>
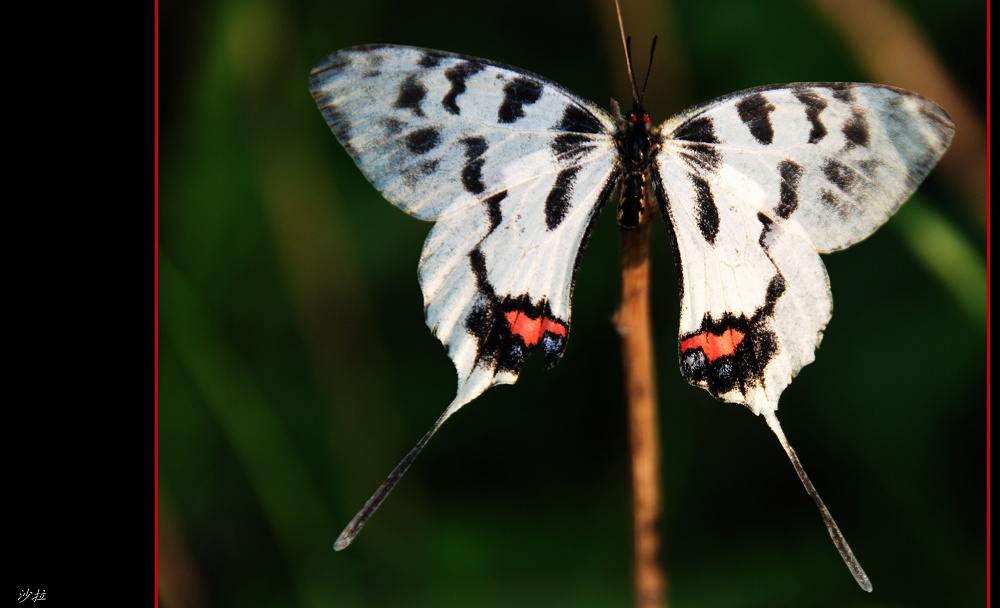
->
<box><xmin>616</xmin><ymin>104</ymin><xmax>659</xmax><ymax>228</ymax></box>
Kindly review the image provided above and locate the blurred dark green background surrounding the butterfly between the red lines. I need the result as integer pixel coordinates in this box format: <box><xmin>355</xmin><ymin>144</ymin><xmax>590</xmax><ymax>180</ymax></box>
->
<box><xmin>159</xmin><ymin>0</ymin><xmax>986</xmax><ymax>608</ymax></box>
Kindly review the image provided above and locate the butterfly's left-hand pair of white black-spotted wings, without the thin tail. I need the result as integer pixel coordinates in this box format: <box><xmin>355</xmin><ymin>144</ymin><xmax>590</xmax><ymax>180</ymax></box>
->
<box><xmin>311</xmin><ymin>45</ymin><xmax>617</xmax><ymax>416</ymax></box>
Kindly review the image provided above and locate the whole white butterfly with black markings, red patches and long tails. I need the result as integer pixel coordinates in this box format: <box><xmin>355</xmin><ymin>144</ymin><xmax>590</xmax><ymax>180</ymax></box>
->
<box><xmin>310</xmin><ymin>27</ymin><xmax>954</xmax><ymax>591</ymax></box>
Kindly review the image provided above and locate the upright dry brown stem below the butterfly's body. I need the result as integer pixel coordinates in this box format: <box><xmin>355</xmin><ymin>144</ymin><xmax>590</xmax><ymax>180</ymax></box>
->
<box><xmin>615</xmin><ymin>214</ymin><xmax>667</xmax><ymax>608</ymax></box>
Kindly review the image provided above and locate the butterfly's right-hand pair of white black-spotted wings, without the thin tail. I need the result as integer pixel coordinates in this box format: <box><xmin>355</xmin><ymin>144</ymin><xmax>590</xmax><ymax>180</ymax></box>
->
<box><xmin>654</xmin><ymin>84</ymin><xmax>954</xmax><ymax>414</ymax></box>
